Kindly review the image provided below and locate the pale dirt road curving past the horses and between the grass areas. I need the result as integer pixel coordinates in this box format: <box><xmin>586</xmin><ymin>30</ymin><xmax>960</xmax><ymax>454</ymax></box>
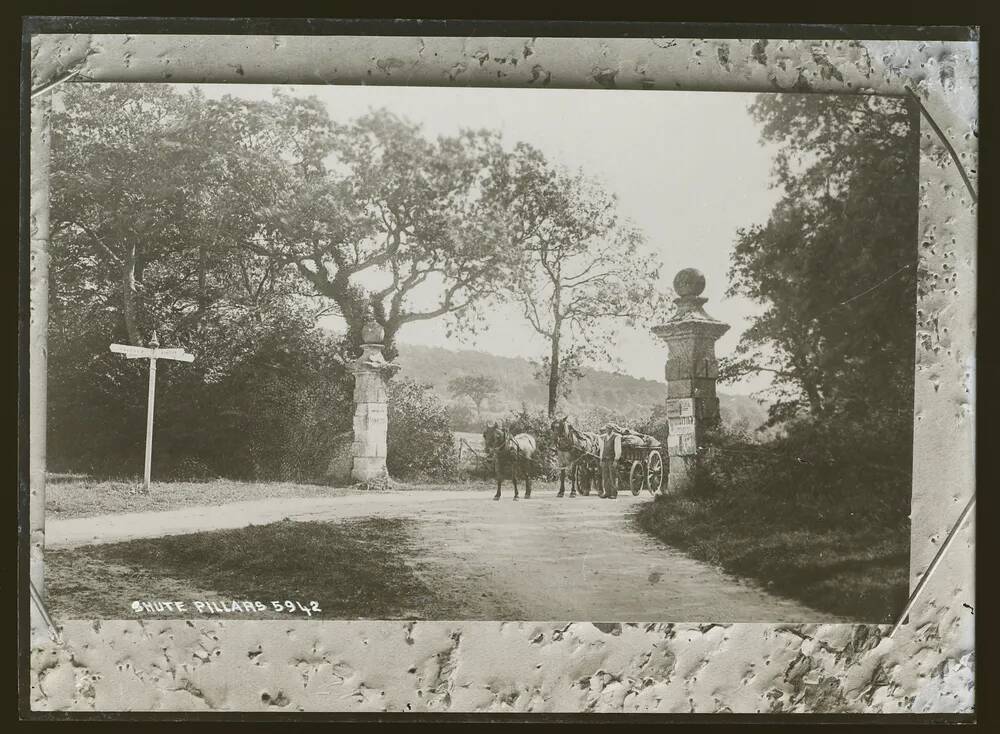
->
<box><xmin>46</xmin><ymin>485</ymin><xmax>840</xmax><ymax>622</ymax></box>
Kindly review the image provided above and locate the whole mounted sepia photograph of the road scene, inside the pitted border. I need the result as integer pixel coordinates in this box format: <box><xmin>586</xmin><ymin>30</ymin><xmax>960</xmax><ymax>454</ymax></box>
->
<box><xmin>45</xmin><ymin>79</ymin><xmax>918</xmax><ymax>622</ymax></box>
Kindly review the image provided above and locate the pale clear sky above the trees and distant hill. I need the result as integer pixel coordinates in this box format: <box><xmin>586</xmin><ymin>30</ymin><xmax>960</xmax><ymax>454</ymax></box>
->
<box><xmin>184</xmin><ymin>85</ymin><xmax>779</xmax><ymax>394</ymax></box>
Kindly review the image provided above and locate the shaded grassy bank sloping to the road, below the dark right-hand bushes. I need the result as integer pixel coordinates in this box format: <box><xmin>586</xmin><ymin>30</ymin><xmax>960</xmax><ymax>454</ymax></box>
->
<box><xmin>635</xmin><ymin>493</ymin><xmax>910</xmax><ymax>623</ymax></box>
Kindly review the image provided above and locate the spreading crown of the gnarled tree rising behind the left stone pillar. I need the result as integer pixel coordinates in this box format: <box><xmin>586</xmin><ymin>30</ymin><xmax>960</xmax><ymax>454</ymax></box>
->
<box><xmin>246</xmin><ymin>107</ymin><xmax>528</xmax><ymax>358</ymax></box>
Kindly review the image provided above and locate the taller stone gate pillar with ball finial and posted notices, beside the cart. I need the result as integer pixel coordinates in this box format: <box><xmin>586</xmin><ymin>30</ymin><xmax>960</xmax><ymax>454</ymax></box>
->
<box><xmin>653</xmin><ymin>268</ymin><xmax>729</xmax><ymax>492</ymax></box>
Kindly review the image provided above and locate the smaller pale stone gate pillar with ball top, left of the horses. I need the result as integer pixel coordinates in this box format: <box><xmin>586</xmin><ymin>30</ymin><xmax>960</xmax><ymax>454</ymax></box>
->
<box><xmin>349</xmin><ymin>324</ymin><xmax>399</xmax><ymax>486</ymax></box>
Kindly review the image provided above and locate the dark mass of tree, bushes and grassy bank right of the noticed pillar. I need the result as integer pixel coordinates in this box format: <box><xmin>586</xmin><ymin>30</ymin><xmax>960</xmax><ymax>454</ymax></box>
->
<box><xmin>639</xmin><ymin>95</ymin><xmax>919</xmax><ymax>623</ymax></box>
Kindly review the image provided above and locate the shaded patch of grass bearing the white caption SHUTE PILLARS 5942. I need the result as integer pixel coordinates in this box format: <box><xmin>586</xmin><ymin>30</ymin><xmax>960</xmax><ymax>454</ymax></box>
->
<box><xmin>45</xmin><ymin>517</ymin><xmax>440</xmax><ymax>619</ymax></box>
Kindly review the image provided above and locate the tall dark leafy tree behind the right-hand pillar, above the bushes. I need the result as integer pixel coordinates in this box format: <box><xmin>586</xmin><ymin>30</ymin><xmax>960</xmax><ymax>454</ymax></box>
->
<box><xmin>721</xmin><ymin>95</ymin><xmax>919</xmax><ymax>436</ymax></box>
